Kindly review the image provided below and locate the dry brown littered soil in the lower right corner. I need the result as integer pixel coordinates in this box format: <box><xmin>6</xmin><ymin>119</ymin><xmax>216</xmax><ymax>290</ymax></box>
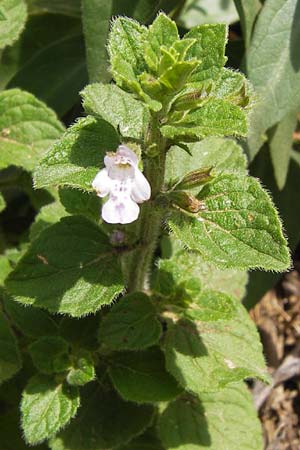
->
<box><xmin>251</xmin><ymin>259</ymin><xmax>300</xmax><ymax>450</ymax></box>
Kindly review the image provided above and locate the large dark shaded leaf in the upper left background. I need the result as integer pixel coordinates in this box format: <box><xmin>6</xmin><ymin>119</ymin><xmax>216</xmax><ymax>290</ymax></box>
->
<box><xmin>1</xmin><ymin>14</ymin><xmax>88</xmax><ymax>116</ymax></box>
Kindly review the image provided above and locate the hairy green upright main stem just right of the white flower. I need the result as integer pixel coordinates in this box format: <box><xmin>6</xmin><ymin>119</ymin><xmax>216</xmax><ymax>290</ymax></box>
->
<box><xmin>128</xmin><ymin>116</ymin><xmax>166</xmax><ymax>292</ymax></box>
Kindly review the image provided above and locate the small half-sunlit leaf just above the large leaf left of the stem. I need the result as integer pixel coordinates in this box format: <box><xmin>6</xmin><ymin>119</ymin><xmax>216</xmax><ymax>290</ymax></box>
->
<box><xmin>30</xmin><ymin>201</ymin><xmax>68</xmax><ymax>240</ymax></box>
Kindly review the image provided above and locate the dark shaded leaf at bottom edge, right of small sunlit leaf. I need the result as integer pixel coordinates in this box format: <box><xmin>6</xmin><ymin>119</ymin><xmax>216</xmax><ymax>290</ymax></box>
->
<box><xmin>50</xmin><ymin>383</ymin><xmax>153</xmax><ymax>450</ymax></box>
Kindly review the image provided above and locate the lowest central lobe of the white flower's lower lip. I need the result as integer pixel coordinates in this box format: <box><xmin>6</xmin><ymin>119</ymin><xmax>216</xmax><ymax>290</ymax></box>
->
<box><xmin>102</xmin><ymin>197</ymin><xmax>140</xmax><ymax>224</ymax></box>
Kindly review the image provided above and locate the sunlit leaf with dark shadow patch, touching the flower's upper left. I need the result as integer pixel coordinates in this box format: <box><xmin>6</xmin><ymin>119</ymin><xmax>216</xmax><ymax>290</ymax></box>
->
<box><xmin>34</xmin><ymin>116</ymin><xmax>119</xmax><ymax>191</ymax></box>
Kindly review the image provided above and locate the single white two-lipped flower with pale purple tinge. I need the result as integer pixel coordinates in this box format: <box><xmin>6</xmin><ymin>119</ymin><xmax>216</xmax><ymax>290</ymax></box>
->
<box><xmin>92</xmin><ymin>145</ymin><xmax>151</xmax><ymax>224</ymax></box>
